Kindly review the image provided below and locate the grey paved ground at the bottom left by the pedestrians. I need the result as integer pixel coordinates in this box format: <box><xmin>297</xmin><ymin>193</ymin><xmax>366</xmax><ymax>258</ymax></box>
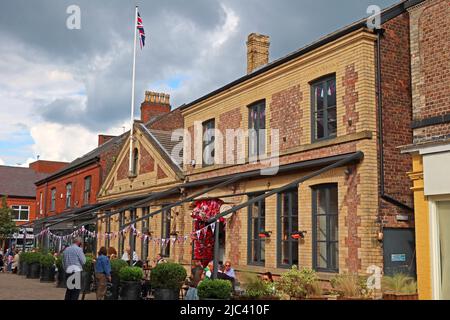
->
<box><xmin>0</xmin><ymin>272</ymin><xmax>95</xmax><ymax>300</ymax></box>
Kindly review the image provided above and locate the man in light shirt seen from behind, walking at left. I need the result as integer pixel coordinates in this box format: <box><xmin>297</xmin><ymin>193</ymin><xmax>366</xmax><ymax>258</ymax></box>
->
<box><xmin>63</xmin><ymin>238</ymin><xmax>86</xmax><ymax>300</ymax></box>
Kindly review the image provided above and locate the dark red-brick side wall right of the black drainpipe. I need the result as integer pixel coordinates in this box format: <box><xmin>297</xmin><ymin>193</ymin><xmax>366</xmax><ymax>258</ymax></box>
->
<box><xmin>380</xmin><ymin>13</ymin><xmax>413</xmax><ymax>221</ymax></box>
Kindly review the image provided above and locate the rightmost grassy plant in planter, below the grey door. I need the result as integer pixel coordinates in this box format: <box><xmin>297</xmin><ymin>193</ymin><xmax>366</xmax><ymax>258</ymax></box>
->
<box><xmin>381</xmin><ymin>273</ymin><xmax>418</xmax><ymax>300</ymax></box>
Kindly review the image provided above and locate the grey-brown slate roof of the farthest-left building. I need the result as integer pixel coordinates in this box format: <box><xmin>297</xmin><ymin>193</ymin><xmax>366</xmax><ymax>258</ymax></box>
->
<box><xmin>0</xmin><ymin>166</ymin><xmax>48</xmax><ymax>198</ymax></box>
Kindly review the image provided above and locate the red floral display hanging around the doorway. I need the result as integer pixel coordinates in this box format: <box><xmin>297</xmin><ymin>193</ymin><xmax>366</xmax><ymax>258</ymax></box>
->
<box><xmin>191</xmin><ymin>199</ymin><xmax>225</xmax><ymax>266</ymax></box>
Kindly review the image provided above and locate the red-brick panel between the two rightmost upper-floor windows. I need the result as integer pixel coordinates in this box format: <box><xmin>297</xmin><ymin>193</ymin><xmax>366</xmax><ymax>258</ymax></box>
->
<box><xmin>270</xmin><ymin>85</ymin><xmax>303</xmax><ymax>152</ymax></box>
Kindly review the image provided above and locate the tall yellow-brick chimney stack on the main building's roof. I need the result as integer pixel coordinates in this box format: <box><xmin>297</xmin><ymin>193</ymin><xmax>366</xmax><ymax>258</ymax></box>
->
<box><xmin>247</xmin><ymin>33</ymin><xmax>270</xmax><ymax>74</ymax></box>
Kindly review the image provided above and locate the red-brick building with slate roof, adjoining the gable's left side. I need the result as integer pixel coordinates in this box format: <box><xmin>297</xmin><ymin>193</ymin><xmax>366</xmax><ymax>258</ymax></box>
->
<box><xmin>30</xmin><ymin>134</ymin><xmax>127</xmax><ymax>246</ymax></box>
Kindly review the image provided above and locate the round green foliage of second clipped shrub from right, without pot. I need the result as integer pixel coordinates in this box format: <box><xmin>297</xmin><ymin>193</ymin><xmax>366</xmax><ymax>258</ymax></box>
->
<box><xmin>150</xmin><ymin>262</ymin><xmax>187</xmax><ymax>290</ymax></box>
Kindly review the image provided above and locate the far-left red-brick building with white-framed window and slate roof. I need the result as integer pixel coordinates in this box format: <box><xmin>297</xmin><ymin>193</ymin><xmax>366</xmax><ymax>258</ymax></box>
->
<box><xmin>0</xmin><ymin>160</ymin><xmax>67</xmax><ymax>249</ymax></box>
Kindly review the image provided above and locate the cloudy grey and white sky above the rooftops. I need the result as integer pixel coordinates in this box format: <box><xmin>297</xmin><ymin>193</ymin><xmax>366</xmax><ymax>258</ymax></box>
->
<box><xmin>0</xmin><ymin>0</ymin><xmax>399</xmax><ymax>165</ymax></box>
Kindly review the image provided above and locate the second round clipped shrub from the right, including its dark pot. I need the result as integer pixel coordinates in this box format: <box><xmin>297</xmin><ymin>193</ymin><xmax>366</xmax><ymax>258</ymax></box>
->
<box><xmin>150</xmin><ymin>262</ymin><xmax>187</xmax><ymax>300</ymax></box>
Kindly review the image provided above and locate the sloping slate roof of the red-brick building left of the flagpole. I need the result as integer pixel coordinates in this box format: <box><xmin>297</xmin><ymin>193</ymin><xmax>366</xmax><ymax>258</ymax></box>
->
<box><xmin>36</xmin><ymin>131</ymin><xmax>129</xmax><ymax>185</ymax></box>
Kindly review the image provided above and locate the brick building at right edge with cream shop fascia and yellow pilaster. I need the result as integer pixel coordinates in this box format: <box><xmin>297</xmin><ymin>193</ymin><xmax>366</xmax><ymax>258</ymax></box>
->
<box><xmin>402</xmin><ymin>0</ymin><xmax>450</xmax><ymax>300</ymax></box>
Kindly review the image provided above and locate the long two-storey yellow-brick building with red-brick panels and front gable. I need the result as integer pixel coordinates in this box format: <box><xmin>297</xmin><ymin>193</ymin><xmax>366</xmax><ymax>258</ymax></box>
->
<box><xmin>93</xmin><ymin>1</ymin><xmax>424</xmax><ymax>278</ymax></box>
